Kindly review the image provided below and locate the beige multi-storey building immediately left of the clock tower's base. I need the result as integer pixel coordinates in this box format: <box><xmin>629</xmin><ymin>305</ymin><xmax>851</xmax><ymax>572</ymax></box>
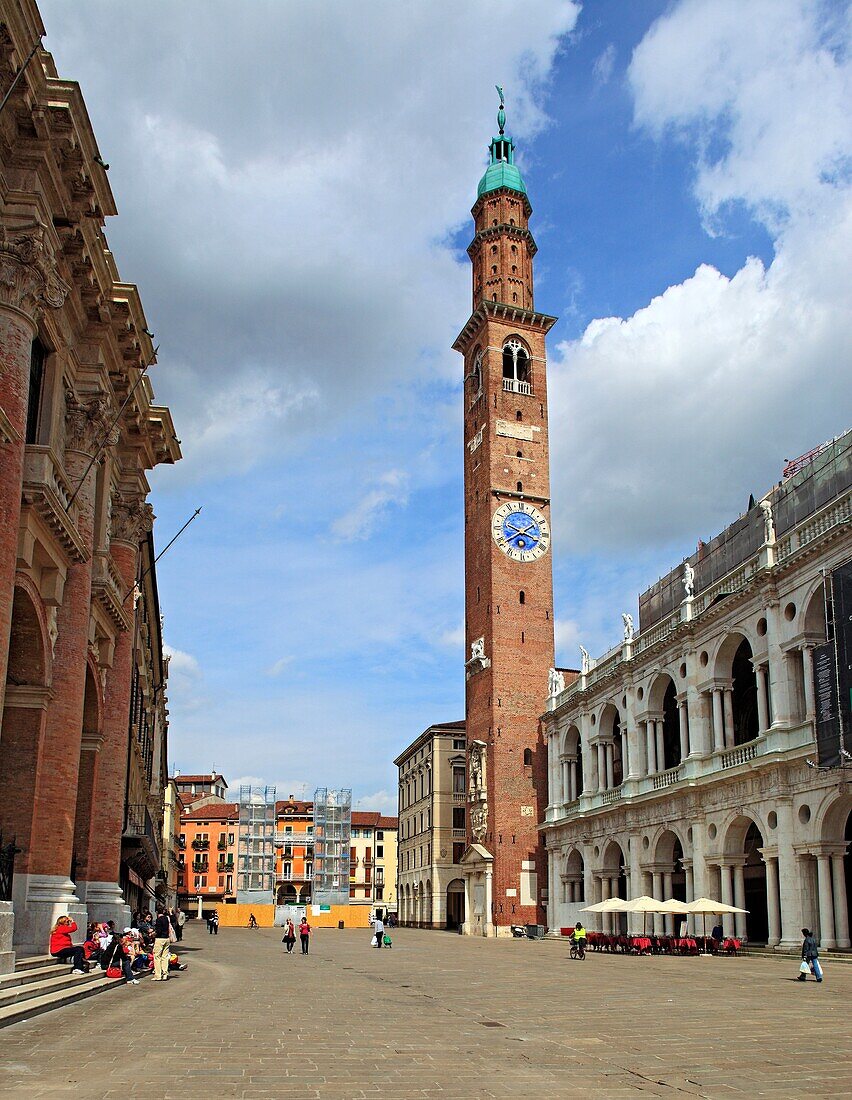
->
<box><xmin>394</xmin><ymin>722</ymin><xmax>467</xmax><ymax>928</ymax></box>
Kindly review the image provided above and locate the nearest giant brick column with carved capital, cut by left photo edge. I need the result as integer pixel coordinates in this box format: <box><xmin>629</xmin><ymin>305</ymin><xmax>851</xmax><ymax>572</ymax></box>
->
<box><xmin>0</xmin><ymin>227</ymin><xmax>68</xmax><ymax>717</ymax></box>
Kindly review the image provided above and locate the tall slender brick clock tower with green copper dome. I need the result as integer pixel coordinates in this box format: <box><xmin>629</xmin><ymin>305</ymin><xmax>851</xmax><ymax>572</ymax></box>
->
<box><xmin>453</xmin><ymin>89</ymin><xmax>556</xmax><ymax>936</ymax></box>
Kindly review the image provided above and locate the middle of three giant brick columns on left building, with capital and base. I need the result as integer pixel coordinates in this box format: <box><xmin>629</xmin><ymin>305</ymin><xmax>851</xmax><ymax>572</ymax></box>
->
<box><xmin>15</xmin><ymin>393</ymin><xmax>108</xmax><ymax>952</ymax></box>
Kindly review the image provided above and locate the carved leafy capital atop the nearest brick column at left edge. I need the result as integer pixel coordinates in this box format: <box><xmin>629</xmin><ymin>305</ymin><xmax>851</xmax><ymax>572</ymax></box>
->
<box><xmin>0</xmin><ymin>218</ymin><xmax>70</xmax><ymax>320</ymax></box>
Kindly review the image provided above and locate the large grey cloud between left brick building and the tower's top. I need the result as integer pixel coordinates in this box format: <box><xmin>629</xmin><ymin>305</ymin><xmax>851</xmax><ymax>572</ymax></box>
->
<box><xmin>42</xmin><ymin>0</ymin><xmax>579</xmax><ymax>484</ymax></box>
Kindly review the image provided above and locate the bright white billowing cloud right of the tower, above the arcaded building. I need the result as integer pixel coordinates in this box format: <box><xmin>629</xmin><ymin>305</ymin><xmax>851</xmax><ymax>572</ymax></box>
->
<box><xmin>551</xmin><ymin>0</ymin><xmax>852</xmax><ymax>553</ymax></box>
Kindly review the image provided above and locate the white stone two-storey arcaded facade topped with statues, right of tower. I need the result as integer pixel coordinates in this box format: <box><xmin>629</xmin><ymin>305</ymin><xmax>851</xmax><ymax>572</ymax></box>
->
<box><xmin>543</xmin><ymin>432</ymin><xmax>852</xmax><ymax>950</ymax></box>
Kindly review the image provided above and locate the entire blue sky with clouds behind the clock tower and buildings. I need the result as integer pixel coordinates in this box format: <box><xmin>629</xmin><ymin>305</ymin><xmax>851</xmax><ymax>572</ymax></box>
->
<box><xmin>41</xmin><ymin>0</ymin><xmax>852</xmax><ymax>810</ymax></box>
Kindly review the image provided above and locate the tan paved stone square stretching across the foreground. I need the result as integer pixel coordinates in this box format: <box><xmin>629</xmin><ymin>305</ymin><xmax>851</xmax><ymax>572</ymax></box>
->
<box><xmin>0</xmin><ymin>925</ymin><xmax>852</xmax><ymax>1100</ymax></box>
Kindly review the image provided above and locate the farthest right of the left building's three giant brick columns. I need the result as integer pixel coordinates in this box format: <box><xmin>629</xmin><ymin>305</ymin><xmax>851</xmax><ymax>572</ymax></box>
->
<box><xmin>79</xmin><ymin>498</ymin><xmax>153</xmax><ymax>924</ymax></box>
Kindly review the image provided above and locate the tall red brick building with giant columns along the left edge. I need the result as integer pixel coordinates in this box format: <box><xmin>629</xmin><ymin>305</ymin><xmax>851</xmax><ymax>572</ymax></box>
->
<box><xmin>0</xmin><ymin>0</ymin><xmax>180</xmax><ymax>950</ymax></box>
